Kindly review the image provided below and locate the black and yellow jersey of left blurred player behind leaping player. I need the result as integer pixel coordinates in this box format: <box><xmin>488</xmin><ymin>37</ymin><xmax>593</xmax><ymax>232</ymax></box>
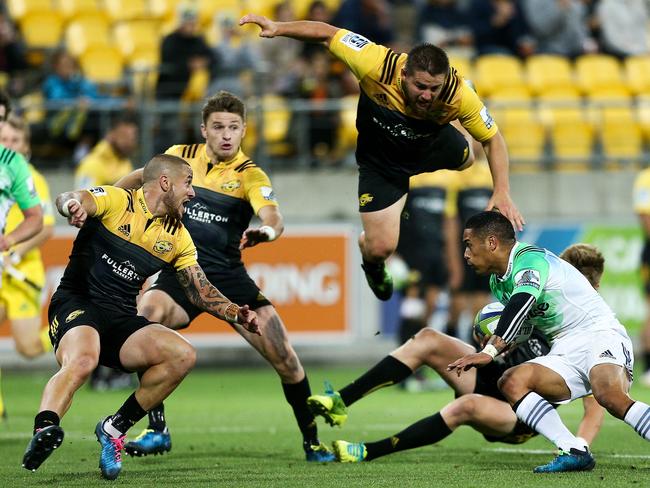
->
<box><xmin>397</xmin><ymin>170</ymin><xmax>456</xmax><ymax>255</ymax></box>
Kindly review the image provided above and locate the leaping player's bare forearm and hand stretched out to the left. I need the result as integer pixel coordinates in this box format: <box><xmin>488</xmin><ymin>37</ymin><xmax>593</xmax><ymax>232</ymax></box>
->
<box><xmin>239</xmin><ymin>14</ymin><xmax>339</xmax><ymax>45</ymax></box>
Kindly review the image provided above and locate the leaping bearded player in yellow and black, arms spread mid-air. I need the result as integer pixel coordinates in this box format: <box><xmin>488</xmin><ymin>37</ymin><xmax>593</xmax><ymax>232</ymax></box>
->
<box><xmin>239</xmin><ymin>14</ymin><xmax>524</xmax><ymax>300</ymax></box>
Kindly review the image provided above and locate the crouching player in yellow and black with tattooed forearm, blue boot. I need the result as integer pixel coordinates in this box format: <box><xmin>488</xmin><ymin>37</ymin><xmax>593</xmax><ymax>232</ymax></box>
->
<box><xmin>23</xmin><ymin>155</ymin><xmax>259</xmax><ymax>479</ymax></box>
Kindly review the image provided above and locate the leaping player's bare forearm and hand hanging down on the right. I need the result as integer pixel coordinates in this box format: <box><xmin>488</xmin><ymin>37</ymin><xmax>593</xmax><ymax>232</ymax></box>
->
<box><xmin>483</xmin><ymin>132</ymin><xmax>526</xmax><ymax>231</ymax></box>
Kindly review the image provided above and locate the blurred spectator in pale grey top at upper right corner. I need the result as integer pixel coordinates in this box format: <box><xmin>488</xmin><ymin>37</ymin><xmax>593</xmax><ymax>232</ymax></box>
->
<box><xmin>596</xmin><ymin>0</ymin><xmax>648</xmax><ymax>57</ymax></box>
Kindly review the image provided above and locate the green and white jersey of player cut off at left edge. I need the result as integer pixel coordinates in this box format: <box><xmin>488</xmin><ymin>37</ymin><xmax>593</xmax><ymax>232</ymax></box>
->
<box><xmin>0</xmin><ymin>145</ymin><xmax>41</xmax><ymax>233</ymax></box>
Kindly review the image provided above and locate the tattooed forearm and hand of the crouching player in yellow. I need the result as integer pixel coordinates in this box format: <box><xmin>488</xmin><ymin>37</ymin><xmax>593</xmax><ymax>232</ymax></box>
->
<box><xmin>176</xmin><ymin>264</ymin><xmax>261</xmax><ymax>335</ymax></box>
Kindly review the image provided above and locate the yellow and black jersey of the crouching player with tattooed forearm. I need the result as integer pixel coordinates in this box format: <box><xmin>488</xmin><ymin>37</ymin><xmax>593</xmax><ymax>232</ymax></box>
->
<box><xmin>59</xmin><ymin>186</ymin><xmax>197</xmax><ymax>313</ymax></box>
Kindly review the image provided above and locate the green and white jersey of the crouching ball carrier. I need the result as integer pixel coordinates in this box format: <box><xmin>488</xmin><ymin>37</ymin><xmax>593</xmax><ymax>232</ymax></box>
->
<box><xmin>490</xmin><ymin>242</ymin><xmax>625</xmax><ymax>343</ymax></box>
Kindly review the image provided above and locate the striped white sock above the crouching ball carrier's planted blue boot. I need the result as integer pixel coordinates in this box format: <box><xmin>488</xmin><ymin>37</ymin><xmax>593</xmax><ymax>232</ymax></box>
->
<box><xmin>515</xmin><ymin>391</ymin><xmax>586</xmax><ymax>452</ymax></box>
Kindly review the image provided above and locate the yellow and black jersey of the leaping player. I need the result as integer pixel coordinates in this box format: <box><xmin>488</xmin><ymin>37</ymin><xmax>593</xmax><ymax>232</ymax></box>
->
<box><xmin>329</xmin><ymin>29</ymin><xmax>498</xmax><ymax>171</ymax></box>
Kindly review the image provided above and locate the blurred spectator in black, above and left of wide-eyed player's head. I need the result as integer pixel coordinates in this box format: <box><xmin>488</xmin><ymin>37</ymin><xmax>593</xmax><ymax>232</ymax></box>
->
<box><xmin>156</xmin><ymin>5</ymin><xmax>212</xmax><ymax>100</ymax></box>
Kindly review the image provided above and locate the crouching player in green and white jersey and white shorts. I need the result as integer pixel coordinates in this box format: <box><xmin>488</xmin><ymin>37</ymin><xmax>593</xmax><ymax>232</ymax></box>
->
<box><xmin>448</xmin><ymin>212</ymin><xmax>650</xmax><ymax>473</ymax></box>
